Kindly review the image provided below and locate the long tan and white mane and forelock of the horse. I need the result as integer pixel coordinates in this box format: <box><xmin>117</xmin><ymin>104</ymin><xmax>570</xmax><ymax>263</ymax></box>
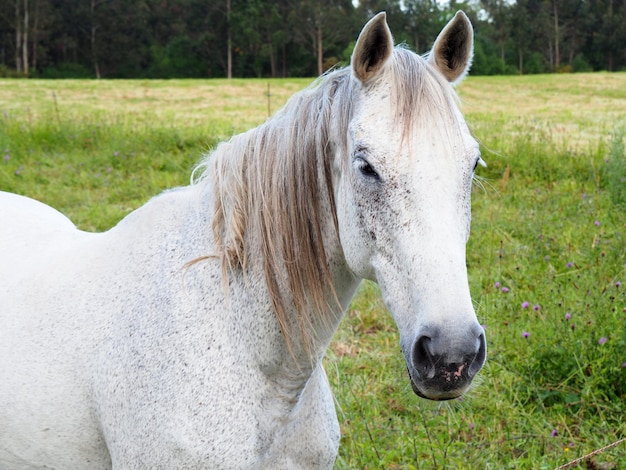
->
<box><xmin>194</xmin><ymin>47</ymin><xmax>456</xmax><ymax>350</ymax></box>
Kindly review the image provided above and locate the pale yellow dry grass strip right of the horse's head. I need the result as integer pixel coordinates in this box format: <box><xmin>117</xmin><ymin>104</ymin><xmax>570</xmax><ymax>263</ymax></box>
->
<box><xmin>459</xmin><ymin>73</ymin><xmax>626</xmax><ymax>150</ymax></box>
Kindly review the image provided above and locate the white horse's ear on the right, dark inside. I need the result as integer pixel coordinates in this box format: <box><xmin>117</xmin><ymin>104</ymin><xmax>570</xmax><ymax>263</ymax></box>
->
<box><xmin>428</xmin><ymin>11</ymin><xmax>474</xmax><ymax>83</ymax></box>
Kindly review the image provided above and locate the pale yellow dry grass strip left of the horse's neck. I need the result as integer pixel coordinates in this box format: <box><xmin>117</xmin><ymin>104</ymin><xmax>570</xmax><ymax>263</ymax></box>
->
<box><xmin>0</xmin><ymin>79</ymin><xmax>311</xmax><ymax>138</ymax></box>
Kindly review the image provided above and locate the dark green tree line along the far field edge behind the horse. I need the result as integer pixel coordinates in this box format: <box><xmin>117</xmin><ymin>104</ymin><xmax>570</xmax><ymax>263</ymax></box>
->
<box><xmin>0</xmin><ymin>0</ymin><xmax>626</xmax><ymax>78</ymax></box>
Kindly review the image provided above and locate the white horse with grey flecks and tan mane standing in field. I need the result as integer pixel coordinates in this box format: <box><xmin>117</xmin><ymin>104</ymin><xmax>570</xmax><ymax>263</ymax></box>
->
<box><xmin>0</xmin><ymin>12</ymin><xmax>486</xmax><ymax>470</ymax></box>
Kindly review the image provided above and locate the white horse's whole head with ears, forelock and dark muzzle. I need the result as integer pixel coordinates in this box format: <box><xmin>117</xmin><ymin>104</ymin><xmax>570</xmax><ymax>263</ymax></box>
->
<box><xmin>334</xmin><ymin>12</ymin><xmax>486</xmax><ymax>400</ymax></box>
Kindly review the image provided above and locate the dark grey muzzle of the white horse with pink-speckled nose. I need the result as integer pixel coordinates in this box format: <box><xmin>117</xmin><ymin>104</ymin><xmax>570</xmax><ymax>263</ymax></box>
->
<box><xmin>407</xmin><ymin>326</ymin><xmax>487</xmax><ymax>400</ymax></box>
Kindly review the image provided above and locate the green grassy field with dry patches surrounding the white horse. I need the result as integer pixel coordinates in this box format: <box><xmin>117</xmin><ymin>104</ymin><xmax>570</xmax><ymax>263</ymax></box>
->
<box><xmin>0</xmin><ymin>73</ymin><xmax>626</xmax><ymax>469</ymax></box>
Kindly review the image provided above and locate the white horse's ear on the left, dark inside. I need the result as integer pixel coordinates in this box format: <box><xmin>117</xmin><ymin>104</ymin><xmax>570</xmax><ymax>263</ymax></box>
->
<box><xmin>351</xmin><ymin>12</ymin><xmax>393</xmax><ymax>83</ymax></box>
